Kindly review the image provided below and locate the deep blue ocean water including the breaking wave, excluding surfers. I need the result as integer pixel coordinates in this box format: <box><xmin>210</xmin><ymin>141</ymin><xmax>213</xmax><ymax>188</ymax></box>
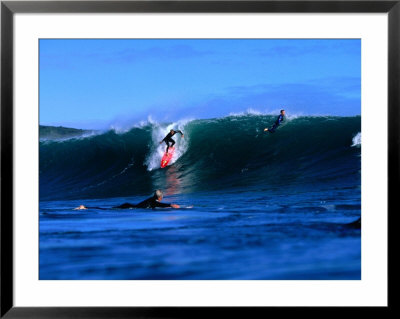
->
<box><xmin>39</xmin><ymin>113</ymin><xmax>361</xmax><ymax>280</ymax></box>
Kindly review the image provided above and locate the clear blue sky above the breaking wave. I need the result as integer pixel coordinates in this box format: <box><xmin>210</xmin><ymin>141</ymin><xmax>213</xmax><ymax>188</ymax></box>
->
<box><xmin>39</xmin><ymin>39</ymin><xmax>361</xmax><ymax>129</ymax></box>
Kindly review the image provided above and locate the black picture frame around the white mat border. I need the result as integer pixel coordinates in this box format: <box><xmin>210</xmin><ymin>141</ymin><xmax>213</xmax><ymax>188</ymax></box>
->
<box><xmin>0</xmin><ymin>0</ymin><xmax>394</xmax><ymax>318</ymax></box>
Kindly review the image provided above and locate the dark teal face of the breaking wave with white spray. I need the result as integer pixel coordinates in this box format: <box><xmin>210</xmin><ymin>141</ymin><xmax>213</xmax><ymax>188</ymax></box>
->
<box><xmin>39</xmin><ymin>114</ymin><xmax>361</xmax><ymax>200</ymax></box>
